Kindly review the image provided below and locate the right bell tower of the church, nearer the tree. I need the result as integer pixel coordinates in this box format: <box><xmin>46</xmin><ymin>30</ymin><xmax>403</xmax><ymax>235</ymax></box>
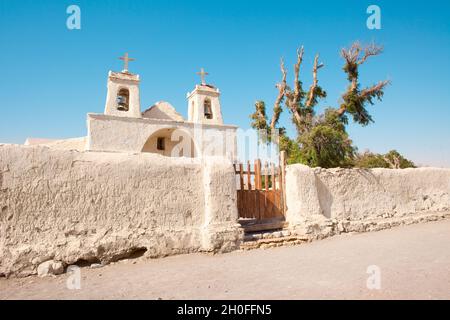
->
<box><xmin>187</xmin><ymin>68</ymin><xmax>223</xmax><ymax>125</ymax></box>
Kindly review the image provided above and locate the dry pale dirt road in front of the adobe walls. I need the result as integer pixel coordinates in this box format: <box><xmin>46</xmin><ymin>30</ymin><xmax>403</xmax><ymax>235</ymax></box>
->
<box><xmin>0</xmin><ymin>220</ymin><xmax>450</xmax><ymax>299</ymax></box>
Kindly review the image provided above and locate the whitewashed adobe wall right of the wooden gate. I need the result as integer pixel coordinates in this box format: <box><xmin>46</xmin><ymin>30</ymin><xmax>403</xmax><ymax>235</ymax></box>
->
<box><xmin>286</xmin><ymin>165</ymin><xmax>450</xmax><ymax>225</ymax></box>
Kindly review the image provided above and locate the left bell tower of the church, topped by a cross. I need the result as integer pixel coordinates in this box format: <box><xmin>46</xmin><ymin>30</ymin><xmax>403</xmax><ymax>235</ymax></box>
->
<box><xmin>105</xmin><ymin>53</ymin><xmax>141</xmax><ymax>118</ymax></box>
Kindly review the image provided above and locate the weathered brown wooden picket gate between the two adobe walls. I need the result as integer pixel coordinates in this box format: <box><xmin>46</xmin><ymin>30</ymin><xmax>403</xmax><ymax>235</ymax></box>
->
<box><xmin>234</xmin><ymin>153</ymin><xmax>286</xmax><ymax>231</ymax></box>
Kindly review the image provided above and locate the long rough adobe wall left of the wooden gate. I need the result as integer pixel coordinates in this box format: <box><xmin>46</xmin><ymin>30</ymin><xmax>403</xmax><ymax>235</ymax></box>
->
<box><xmin>0</xmin><ymin>145</ymin><xmax>242</xmax><ymax>276</ymax></box>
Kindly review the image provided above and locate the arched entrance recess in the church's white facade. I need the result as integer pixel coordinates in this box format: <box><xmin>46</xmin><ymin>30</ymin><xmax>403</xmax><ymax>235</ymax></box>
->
<box><xmin>142</xmin><ymin>128</ymin><xmax>197</xmax><ymax>158</ymax></box>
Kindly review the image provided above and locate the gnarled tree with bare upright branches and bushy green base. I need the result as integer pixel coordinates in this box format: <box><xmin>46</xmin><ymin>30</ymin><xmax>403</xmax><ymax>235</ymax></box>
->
<box><xmin>251</xmin><ymin>42</ymin><xmax>389</xmax><ymax>166</ymax></box>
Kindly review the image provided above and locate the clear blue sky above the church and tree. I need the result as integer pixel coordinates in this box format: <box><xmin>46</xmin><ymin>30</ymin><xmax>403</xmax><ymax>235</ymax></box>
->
<box><xmin>0</xmin><ymin>0</ymin><xmax>450</xmax><ymax>166</ymax></box>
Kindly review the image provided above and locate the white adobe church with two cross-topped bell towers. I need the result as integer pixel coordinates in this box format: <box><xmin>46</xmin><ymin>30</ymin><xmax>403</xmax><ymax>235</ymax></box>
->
<box><xmin>25</xmin><ymin>54</ymin><xmax>237</xmax><ymax>161</ymax></box>
